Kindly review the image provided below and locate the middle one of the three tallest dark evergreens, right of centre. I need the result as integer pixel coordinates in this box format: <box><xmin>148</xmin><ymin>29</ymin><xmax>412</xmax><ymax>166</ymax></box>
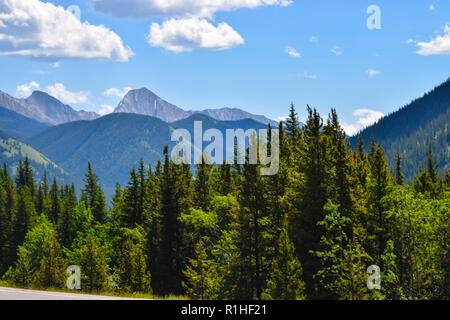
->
<box><xmin>286</xmin><ymin>106</ymin><xmax>331</xmax><ymax>296</ymax></box>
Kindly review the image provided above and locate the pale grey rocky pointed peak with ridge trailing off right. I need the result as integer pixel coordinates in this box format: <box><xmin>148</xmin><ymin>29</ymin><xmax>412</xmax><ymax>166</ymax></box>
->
<box><xmin>114</xmin><ymin>88</ymin><xmax>278</xmax><ymax>126</ymax></box>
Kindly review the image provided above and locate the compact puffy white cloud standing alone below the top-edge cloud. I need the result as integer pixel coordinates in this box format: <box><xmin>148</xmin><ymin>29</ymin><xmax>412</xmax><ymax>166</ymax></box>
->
<box><xmin>148</xmin><ymin>18</ymin><xmax>244</xmax><ymax>53</ymax></box>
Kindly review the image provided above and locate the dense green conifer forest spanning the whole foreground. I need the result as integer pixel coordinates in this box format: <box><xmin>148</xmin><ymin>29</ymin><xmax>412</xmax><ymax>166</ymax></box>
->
<box><xmin>0</xmin><ymin>106</ymin><xmax>450</xmax><ymax>300</ymax></box>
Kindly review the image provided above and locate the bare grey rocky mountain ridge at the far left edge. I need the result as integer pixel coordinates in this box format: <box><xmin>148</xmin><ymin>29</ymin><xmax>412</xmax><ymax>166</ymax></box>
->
<box><xmin>0</xmin><ymin>91</ymin><xmax>100</xmax><ymax>125</ymax></box>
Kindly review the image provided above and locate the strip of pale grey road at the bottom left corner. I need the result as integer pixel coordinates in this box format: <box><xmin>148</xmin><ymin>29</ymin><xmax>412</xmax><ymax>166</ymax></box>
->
<box><xmin>0</xmin><ymin>287</ymin><xmax>144</xmax><ymax>300</ymax></box>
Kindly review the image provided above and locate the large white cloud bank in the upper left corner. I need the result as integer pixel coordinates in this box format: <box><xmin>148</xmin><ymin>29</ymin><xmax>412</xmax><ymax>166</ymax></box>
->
<box><xmin>0</xmin><ymin>0</ymin><xmax>134</xmax><ymax>61</ymax></box>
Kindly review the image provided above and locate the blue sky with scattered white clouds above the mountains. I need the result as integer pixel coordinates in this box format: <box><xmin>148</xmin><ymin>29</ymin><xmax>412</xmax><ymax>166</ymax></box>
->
<box><xmin>0</xmin><ymin>0</ymin><xmax>450</xmax><ymax>132</ymax></box>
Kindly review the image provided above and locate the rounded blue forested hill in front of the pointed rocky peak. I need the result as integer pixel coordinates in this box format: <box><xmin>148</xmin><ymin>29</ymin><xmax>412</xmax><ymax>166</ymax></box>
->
<box><xmin>28</xmin><ymin>113</ymin><xmax>265</xmax><ymax>195</ymax></box>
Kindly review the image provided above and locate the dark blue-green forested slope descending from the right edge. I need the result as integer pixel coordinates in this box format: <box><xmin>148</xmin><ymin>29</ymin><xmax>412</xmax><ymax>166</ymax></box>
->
<box><xmin>350</xmin><ymin>79</ymin><xmax>450</xmax><ymax>181</ymax></box>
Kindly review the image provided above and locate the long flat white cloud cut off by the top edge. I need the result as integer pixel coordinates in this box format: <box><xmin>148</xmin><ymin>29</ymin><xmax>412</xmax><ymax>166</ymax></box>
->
<box><xmin>90</xmin><ymin>0</ymin><xmax>292</xmax><ymax>19</ymax></box>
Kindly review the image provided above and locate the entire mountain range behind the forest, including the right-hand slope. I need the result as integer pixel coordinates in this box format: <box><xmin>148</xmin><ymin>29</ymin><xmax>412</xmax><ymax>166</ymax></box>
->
<box><xmin>0</xmin><ymin>79</ymin><xmax>450</xmax><ymax>195</ymax></box>
